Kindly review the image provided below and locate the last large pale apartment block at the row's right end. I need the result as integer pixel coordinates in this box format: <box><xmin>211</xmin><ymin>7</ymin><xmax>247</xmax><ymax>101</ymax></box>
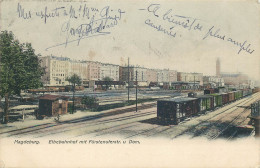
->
<box><xmin>177</xmin><ymin>72</ymin><xmax>203</xmax><ymax>86</ymax></box>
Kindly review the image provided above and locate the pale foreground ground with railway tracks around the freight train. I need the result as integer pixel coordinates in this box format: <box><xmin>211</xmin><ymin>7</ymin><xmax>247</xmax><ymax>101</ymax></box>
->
<box><xmin>0</xmin><ymin>92</ymin><xmax>260</xmax><ymax>140</ymax></box>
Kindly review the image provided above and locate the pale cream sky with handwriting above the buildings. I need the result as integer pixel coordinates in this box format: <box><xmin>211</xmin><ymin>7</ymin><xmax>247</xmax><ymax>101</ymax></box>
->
<box><xmin>0</xmin><ymin>0</ymin><xmax>260</xmax><ymax>80</ymax></box>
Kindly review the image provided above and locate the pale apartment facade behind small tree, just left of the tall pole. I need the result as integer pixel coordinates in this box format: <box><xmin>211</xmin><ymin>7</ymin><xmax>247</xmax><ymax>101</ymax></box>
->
<box><xmin>99</xmin><ymin>64</ymin><xmax>119</xmax><ymax>81</ymax></box>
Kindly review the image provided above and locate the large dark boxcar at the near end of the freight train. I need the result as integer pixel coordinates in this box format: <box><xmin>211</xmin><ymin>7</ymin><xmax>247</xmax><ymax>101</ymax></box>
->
<box><xmin>157</xmin><ymin>97</ymin><xmax>199</xmax><ymax>125</ymax></box>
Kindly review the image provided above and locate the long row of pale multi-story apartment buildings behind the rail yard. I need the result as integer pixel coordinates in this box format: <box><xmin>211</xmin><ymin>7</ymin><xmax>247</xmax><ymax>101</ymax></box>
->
<box><xmin>40</xmin><ymin>56</ymin><xmax>252</xmax><ymax>87</ymax></box>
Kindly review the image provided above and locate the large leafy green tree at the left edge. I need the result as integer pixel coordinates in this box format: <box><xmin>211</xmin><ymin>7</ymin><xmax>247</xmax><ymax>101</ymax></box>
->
<box><xmin>0</xmin><ymin>31</ymin><xmax>45</xmax><ymax>123</ymax></box>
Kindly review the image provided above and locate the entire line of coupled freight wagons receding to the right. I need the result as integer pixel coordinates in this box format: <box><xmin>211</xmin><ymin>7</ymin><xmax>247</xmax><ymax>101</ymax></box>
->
<box><xmin>157</xmin><ymin>88</ymin><xmax>259</xmax><ymax>125</ymax></box>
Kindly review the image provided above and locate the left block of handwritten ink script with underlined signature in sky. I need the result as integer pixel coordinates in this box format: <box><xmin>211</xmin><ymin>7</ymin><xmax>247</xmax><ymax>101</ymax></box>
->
<box><xmin>17</xmin><ymin>3</ymin><xmax>125</xmax><ymax>50</ymax></box>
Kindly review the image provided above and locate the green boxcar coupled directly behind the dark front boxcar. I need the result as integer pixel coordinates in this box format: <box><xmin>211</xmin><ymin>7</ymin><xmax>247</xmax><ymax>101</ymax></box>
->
<box><xmin>197</xmin><ymin>95</ymin><xmax>214</xmax><ymax>113</ymax></box>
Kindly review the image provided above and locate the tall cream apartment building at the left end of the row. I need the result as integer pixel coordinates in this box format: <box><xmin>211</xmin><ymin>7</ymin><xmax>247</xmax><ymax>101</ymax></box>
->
<box><xmin>40</xmin><ymin>56</ymin><xmax>70</xmax><ymax>86</ymax></box>
